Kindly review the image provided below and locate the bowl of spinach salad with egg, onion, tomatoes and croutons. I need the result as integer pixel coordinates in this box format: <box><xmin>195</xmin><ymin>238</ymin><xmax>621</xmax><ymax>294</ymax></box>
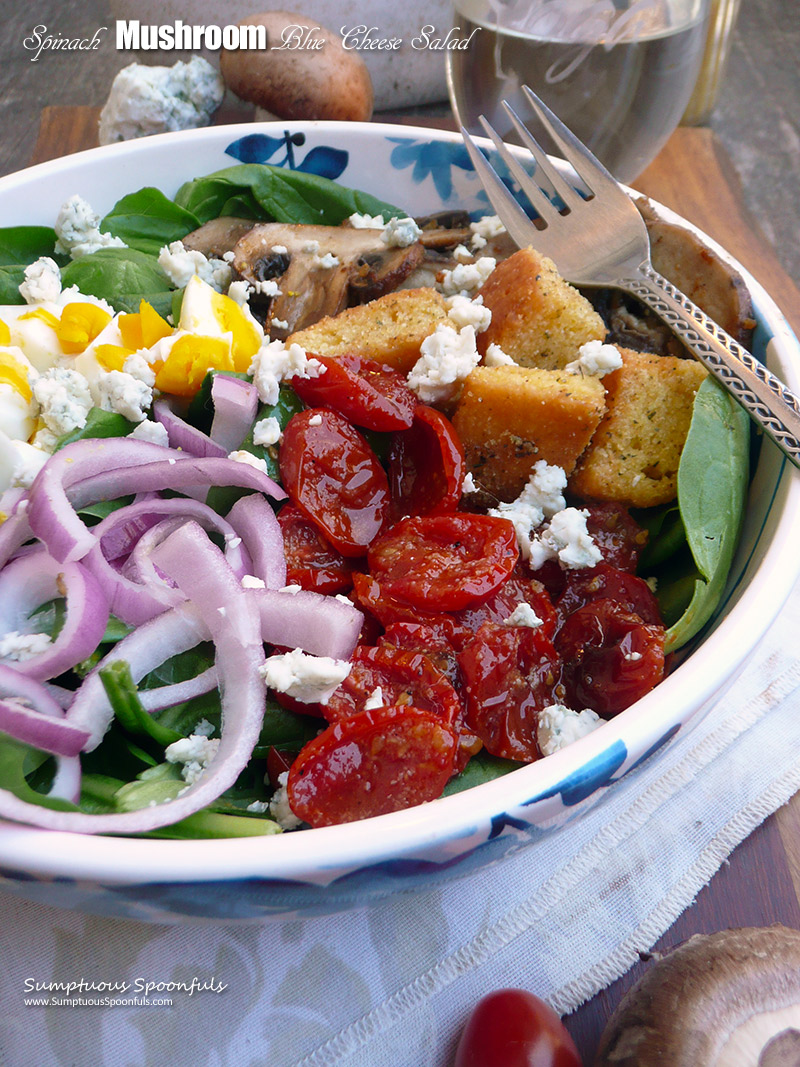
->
<box><xmin>0</xmin><ymin>124</ymin><xmax>793</xmax><ymax>913</ymax></box>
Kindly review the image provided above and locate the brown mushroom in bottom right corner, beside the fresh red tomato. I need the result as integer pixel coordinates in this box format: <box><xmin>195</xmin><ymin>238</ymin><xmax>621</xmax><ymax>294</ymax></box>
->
<box><xmin>595</xmin><ymin>925</ymin><xmax>800</xmax><ymax>1067</ymax></box>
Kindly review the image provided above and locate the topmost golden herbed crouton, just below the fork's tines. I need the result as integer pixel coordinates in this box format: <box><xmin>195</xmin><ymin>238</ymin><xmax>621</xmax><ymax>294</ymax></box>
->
<box><xmin>479</xmin><ymin>249</ymin><xmax>606</xmax><ymax>370</ymax></box>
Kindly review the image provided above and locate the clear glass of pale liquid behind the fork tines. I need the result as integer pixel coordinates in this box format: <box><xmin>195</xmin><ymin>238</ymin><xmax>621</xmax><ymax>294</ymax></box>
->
<box><xmin>447</xmin><ymin>0</ymin><xmax>708</xmax><ymax>181</ymax></box>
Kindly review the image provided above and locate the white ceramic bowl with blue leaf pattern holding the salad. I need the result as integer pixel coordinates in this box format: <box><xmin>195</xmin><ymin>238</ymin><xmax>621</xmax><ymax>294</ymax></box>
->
<box><xmin>0</xmin><ymin>123</ymin><xmax>800</xmax><ymax>922</ymax></box>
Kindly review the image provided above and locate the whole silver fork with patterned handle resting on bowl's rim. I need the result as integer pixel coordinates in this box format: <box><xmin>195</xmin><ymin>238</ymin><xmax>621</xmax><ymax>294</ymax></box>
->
<box><xmin>461</xmin><ymin>85</ymin><xmax>800</xmax><ymax>467</ymax></box>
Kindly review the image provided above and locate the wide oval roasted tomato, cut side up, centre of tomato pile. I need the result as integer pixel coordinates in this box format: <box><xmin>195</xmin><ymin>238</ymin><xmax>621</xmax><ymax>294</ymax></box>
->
<box><xmin>367</xmin><ymin>514</ymin><xmax>518</xmax><ymax>611</ymax></box>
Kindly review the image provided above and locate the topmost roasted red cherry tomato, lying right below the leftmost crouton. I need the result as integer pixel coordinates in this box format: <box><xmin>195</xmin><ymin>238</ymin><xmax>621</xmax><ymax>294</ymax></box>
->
<box><xmin>289</xmin><ymin>353</ymin><xmax>419</xmax><ymax>430</ymax></box>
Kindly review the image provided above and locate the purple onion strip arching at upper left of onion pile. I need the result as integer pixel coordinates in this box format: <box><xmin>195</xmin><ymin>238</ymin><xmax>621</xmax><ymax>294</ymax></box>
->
<box><xmin>27</xmin><ymin>437</ymin><xmax>193</xmax><ymax>562</ymax></box>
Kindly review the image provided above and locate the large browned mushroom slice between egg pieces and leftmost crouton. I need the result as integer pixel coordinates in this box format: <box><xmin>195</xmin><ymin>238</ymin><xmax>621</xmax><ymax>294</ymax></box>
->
<box><xmin>233</xmin><ymin>222</ymin><xmax>425</xmax><ymax>338</ymax></box>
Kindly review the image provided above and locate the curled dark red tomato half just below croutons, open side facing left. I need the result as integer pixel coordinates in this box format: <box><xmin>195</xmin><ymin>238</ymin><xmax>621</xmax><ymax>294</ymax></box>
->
<box><xmin>389</xmin><ymin>404</ymin><xmax>465</xmax><ymax>519</ymax></box>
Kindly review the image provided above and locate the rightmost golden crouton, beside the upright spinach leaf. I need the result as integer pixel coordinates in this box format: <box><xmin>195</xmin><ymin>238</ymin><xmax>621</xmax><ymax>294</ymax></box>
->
<box><xmin>570</xmin><ymin>349</ymin><xmax>706</xmax><ymax>508</ymax></box>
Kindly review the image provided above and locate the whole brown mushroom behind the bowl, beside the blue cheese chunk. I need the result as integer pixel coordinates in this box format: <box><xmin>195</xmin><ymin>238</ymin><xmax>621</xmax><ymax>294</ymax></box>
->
<box><xmin>220</xmin><ymin>11</ymin><xmax>372</xmax><ymax>122</ymax></box>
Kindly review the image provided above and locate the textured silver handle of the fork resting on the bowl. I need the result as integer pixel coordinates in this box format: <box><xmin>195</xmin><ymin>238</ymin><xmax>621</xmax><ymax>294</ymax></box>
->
<box><xmin>617</xmin><ymin>261</ymin><xmax>800</xmax><ymax>467</ymax></box>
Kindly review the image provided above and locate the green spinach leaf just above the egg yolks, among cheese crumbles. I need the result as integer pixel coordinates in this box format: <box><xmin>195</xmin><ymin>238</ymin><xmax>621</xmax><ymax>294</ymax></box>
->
<box><xmin>61</xmin><ymin>249</ymin><xmax>173</xmax><ymax>315</ymax></box>
